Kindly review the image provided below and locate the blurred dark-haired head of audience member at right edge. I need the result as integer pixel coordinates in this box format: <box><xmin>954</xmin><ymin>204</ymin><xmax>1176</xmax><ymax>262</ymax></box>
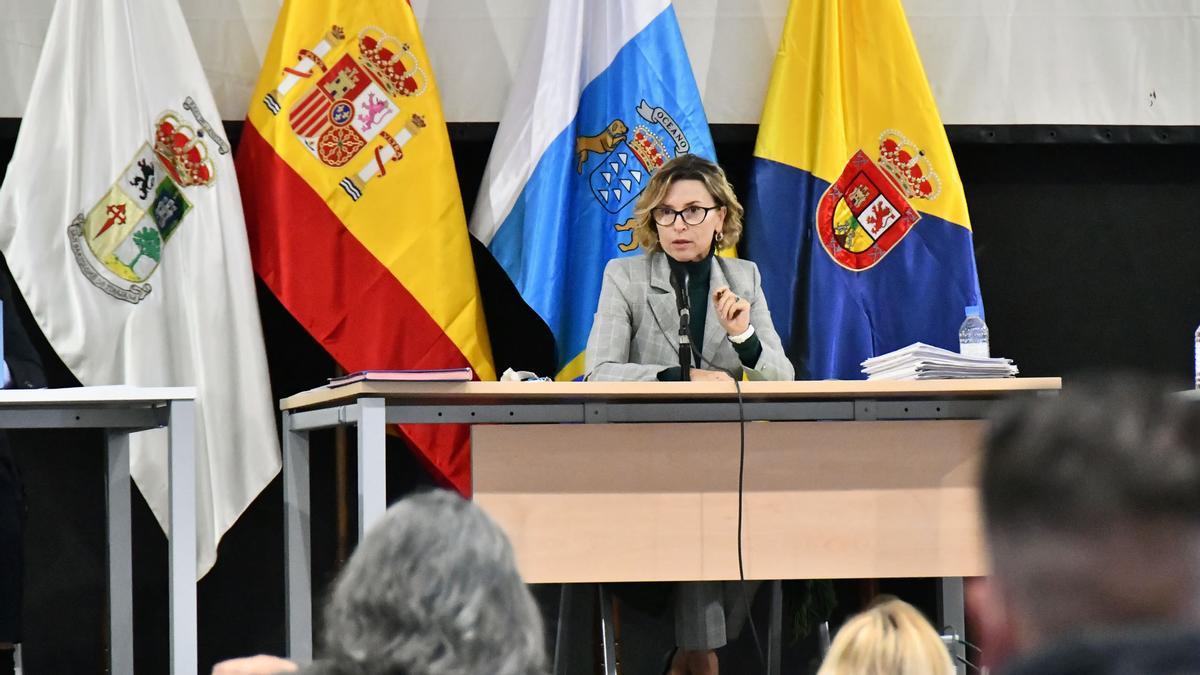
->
<box><xmin>979</xmin><ymin>376</ymin><xmax>1200</xmax><ymax>651</ymax></box>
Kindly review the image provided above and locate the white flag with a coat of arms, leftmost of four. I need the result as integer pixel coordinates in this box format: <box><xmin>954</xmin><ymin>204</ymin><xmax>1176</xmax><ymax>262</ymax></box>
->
<box><xmin>0</xmin><ymin>0</ymin><xmax>280</xmax><ymax>575</ymax></box>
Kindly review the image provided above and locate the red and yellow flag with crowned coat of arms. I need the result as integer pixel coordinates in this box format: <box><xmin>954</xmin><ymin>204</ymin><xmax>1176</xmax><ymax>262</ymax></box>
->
<box><xmin>238</xmin><ymin>0</ymin><xmax>496</xmax><ymax>494</ymax></box>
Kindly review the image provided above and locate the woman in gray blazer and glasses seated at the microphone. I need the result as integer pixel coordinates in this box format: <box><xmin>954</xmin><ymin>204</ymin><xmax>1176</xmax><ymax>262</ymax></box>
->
<box><xmin>584</xmin><ymin>155</ymin><xmax>796</xmax><ymax>675</ymax></box>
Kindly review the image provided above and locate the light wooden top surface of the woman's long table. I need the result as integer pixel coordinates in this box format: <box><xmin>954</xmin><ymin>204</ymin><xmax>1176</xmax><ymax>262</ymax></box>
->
<box><xmin>280</xmin><ymin>377</ymin><xmax>1062</xmax><ymax>411</ymax></box>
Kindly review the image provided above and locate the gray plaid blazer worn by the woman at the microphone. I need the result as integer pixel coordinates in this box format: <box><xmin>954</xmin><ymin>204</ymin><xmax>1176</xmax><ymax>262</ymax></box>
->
<box><xmin>584</xmin><ymin>251</ymin><xmax>796</xmax><ymax>381</ymax></box>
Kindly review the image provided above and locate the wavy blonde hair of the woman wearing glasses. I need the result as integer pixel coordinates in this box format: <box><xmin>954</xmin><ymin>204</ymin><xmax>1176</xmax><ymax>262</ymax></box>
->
<box><xmin>634</xmin><ymin>154</ymin><xmax>745</xmax><ymax>252</ymax></box>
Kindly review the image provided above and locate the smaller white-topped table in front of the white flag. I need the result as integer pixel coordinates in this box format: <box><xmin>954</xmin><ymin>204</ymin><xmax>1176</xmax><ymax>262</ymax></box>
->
<box><xmin>0</xmin><ymin>386</ymin><xmax>198</xmax><ymax>675</ymax></box>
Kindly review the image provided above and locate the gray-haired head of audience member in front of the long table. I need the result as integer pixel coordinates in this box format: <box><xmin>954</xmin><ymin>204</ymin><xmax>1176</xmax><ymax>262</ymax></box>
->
<box><xmin>316</xmin><ymin>490</ymin><xmax>546</xmax><ymax>675</ymax></box>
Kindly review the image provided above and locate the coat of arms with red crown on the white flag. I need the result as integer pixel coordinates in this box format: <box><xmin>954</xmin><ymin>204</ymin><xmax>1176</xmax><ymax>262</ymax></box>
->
<box><xmin>67</xmin><ymin>105</ymin><xmax>224</xmax><ymax>304</ymax></box>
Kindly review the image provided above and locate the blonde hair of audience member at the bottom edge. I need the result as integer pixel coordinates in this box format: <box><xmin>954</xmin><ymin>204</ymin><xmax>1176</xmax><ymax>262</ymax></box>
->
<box><xmin>817</xmin><ymin>598</ymin><xmax>954</xmax><ymax>675</ymax></box>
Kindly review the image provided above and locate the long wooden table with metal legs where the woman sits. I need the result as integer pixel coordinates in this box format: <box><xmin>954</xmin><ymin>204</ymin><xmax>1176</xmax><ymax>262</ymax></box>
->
<box><xmin>280</xmin><ymin>378</ymin><xmax>1061</xmax><ymax>659</ymax></box>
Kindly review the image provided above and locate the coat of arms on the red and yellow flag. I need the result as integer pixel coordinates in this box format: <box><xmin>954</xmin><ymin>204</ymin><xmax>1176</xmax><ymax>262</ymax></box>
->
<box><xmin>263</xmin><ymin>25</ymin><xmax>428</xmax><ymax>201</ymax></box>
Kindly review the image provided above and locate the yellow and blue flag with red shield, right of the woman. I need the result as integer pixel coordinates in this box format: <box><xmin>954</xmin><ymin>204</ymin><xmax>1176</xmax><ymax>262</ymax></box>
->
<box><xmin>745</xmin><ymin>0</ymin><xmax>983</xmax><ymax>380</ymax></box>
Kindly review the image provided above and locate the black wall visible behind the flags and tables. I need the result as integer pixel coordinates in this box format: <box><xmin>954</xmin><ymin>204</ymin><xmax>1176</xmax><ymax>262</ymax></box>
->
<box><xmin>0</xmin><ymin>120</ymin><xmax>1200</xmax><ymax>675</ymax></box>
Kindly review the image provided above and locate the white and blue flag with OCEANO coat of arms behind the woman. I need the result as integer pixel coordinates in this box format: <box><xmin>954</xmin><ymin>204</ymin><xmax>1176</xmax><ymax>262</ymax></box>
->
<box><xmin>470</xmin><ymin>0</ymin><xmax>716</xmax><ymax>380</ymax></box>
